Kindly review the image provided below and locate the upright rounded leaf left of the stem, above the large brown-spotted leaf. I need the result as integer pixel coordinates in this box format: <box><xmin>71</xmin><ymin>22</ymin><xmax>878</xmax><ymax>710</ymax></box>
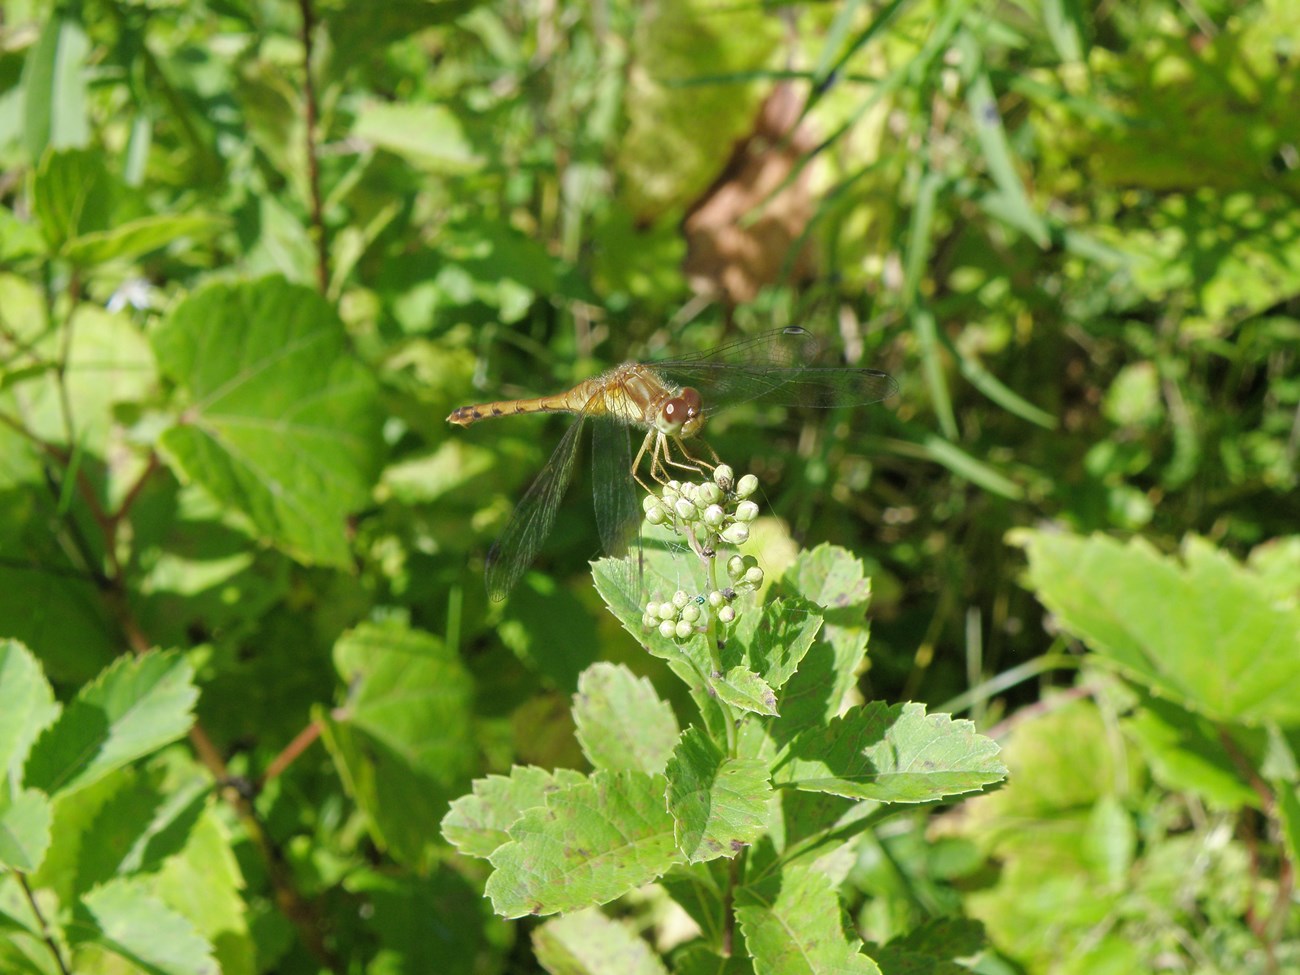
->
<box><xmin>573</xmin><ymin>663</ymin><xmax>680</xmax><ymax>772</ymax></box>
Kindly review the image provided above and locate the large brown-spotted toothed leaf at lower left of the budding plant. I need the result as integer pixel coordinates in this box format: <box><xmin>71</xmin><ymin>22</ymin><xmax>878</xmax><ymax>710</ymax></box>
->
<box><xmin>486</xmin><ymin>772</ymin><xmax>683</xmax><ymax>918</ymax></box>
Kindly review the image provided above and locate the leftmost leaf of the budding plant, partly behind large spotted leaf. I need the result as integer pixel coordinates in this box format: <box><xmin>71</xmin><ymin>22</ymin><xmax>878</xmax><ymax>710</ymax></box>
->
<box><xmin>442</xmin><ymin>766</ymin><xmax>586</xmax><ymax>857</ymax></box>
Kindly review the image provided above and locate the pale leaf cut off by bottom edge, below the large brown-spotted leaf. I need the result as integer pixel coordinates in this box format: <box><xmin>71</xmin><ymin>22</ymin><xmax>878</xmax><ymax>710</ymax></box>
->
<box><xmin>533</xmin><ymin>909</ymin><xmax>668</xmax><ymax>975</ymax></box>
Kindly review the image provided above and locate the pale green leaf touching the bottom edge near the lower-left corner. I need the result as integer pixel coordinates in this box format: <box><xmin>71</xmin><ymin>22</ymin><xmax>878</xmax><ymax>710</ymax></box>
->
<box><xmin>69</xmin><ymin>880</ymin><xmax>216</xmax><ymax>975</ymax></box>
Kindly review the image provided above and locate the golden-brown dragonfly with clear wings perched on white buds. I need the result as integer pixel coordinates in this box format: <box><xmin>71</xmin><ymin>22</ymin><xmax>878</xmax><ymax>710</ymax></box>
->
<box><xmin>447</xmin><ymin>325</ymin><xmax>898</xmax><ymax>602</ymax></box>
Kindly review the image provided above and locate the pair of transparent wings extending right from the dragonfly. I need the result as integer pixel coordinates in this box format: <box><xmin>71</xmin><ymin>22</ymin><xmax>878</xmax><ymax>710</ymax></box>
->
<box><xmin>650</xmin><ymin>328</ymin><xmax>898</xmax><ymax>410</ymax></box>
